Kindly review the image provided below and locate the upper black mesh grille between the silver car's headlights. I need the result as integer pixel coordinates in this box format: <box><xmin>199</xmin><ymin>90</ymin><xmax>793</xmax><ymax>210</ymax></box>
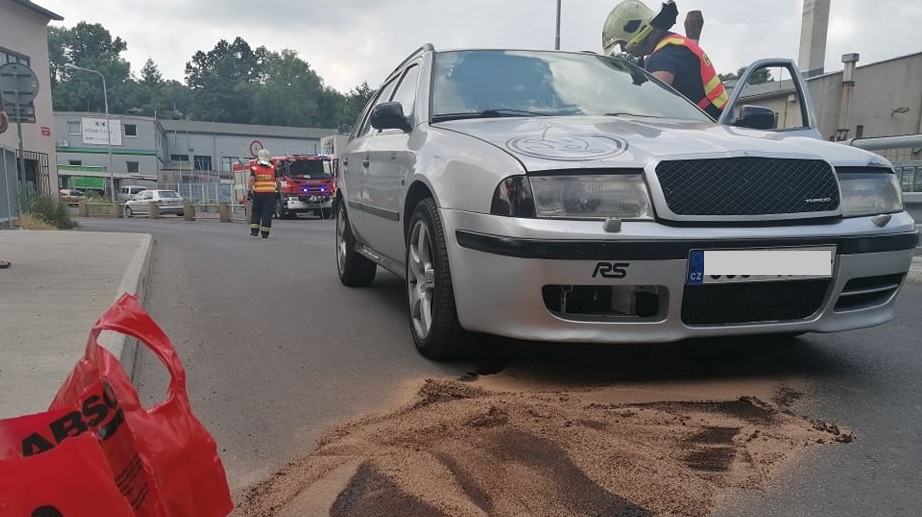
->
<box><xmin>656</xmin><ymin>157</ymin><xmax>839</xmax><ymax>219</ymax></box>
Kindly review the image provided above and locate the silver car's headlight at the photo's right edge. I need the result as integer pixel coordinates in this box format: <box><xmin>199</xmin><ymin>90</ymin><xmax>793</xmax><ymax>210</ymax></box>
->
<box><xmin>839</xmin><ymin>172</ymin><xmax>903</xmax><ymax>217</ymax></box>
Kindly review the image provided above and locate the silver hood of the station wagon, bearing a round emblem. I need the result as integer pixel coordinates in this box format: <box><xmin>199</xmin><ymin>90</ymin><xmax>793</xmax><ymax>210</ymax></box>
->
<box><xmin>434</xmin><ymin>117</ymin><xmax>888</xmax><ymax>171</ymax></box>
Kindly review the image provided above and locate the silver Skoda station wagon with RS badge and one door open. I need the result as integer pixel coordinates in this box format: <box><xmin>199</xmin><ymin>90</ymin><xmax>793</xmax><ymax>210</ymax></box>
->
<box><xmin>336</xmin><ymin>45</ymin><xmax>918</xmax><ymax>360</ymax></box>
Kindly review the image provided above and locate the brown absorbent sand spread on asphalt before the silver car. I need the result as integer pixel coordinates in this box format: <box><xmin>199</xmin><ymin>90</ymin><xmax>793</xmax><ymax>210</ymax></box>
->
<box><xmin>235</xmin><ymin>377</ymin><xmax>853</xmax><ymax>517</ymax></box>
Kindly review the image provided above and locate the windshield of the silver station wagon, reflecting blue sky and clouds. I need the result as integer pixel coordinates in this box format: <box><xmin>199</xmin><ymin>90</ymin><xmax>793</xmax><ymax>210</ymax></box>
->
<box><xmin>431</xmin><ymin>50</ymin><xmax>710</xmax><ymax>122</ymax></box>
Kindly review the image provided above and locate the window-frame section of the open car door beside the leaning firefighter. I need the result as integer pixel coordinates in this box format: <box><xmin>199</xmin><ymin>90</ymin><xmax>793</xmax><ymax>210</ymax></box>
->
<box><xmin>718</xmin><ymin>58</ymin><xmax>823</xmax><ymax>139</ymax></box>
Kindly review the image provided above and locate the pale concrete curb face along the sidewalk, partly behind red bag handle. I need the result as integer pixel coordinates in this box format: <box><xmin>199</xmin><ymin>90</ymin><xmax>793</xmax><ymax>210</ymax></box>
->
<box><xmin>99</xmin><ymin>234</ymin><xmax>154</xmax><ymax>381</ymax></box>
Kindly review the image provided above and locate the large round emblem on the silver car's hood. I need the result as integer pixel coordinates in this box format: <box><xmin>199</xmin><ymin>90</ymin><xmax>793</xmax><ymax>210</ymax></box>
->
<box><xmin>506</xmin><ymin>131</ymin><xmax>628</xmax><ymax>161</ymax></box>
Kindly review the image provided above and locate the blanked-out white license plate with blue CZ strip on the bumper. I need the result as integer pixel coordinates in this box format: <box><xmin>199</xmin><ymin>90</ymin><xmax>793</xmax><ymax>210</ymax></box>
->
<box><xmin>686</xmin><ymin>246</ymin><xmax>836</xmax><ymax>285</ymax></box>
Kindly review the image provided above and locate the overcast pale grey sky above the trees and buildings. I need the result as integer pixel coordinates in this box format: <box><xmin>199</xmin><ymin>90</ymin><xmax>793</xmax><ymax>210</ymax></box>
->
<box><xmin>39</xmin><ymin>0</ymin><xmax>922</xmax><ymax>93</ymax></box>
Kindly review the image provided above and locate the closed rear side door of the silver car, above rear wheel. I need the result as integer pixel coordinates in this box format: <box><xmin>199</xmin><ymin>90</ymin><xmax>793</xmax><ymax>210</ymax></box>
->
<box><xmin>342</xmin><ymin>78</ymin><xmax>397</xmax><ymax>243</ymax></box>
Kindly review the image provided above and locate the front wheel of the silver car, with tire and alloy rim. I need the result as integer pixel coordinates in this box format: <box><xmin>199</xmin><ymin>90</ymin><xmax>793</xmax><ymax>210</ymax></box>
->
<box><xmin>406</xmin><ymin>198</ymin><xmax>470</xmax><ymax>361</ymax></box>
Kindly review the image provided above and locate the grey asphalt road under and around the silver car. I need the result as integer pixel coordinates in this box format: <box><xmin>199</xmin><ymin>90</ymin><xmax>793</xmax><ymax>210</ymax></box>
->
<box><xmin>80</xmin><ymin>219</ymin><xmax>922</xmax><ymax>517</ymax></box>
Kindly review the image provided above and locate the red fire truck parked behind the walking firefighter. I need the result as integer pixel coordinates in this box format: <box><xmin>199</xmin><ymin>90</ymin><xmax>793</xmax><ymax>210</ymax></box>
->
<box><xmin>234</xmin><ymin>154</ymin><xmax>336</xmax><ymax>219</ymax></box>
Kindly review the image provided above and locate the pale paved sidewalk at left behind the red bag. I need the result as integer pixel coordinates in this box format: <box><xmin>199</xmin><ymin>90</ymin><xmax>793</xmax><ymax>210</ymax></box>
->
<box><xmin>0</xmin><ymin>230</ymin><xmax>153</xmax><ymax>418</ymax></box>
